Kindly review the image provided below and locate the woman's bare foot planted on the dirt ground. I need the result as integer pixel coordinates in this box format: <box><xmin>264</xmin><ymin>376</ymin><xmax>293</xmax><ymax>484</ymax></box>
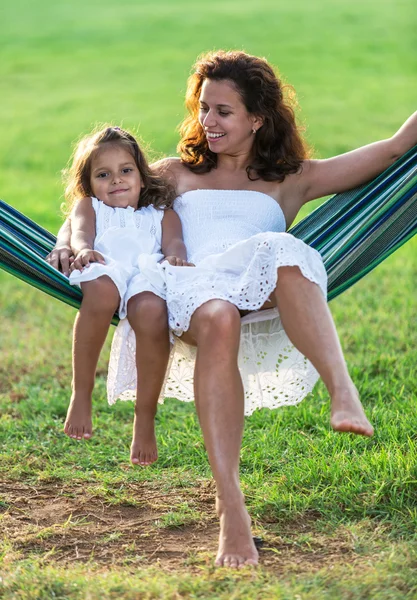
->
<box><xmin>215</xmin><ymin>498</ymin><xmax>258</xmax><ymax>569</ymax></box>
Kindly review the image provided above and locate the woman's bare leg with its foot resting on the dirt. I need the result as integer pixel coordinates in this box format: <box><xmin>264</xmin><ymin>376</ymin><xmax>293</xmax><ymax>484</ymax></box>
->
<box><xmin>183</xmin><ymin>300</ymin><xmax>258</xmax><ymax>568</ymax></box>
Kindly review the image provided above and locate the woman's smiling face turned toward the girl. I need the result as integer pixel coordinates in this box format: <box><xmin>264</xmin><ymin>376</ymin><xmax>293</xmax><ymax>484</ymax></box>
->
<box><xmin>198</xmin><ymin>79</ymin><xmax>262</xmax><ymax>156</ymax></box>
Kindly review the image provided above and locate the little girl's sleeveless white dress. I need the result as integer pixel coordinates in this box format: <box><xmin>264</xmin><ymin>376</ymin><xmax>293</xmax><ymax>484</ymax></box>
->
<box><xmin>69</xmin><ymin>198</ymin><xmax>165</xmax><ymax>318</ymax></box>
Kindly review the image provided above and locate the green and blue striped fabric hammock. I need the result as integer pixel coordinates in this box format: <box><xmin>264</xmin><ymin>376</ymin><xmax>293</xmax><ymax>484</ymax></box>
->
<box><xmin>0</xmin><ymin>146</ymin><xmax>417</xmax><ymax>322</ymax></box>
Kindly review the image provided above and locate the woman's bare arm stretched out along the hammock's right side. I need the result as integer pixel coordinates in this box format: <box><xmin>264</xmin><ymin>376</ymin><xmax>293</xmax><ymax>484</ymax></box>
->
<box><xmin>299</xmin><ymin>112</ymin><xmax>417</xmax><ymax>204</ymax></box>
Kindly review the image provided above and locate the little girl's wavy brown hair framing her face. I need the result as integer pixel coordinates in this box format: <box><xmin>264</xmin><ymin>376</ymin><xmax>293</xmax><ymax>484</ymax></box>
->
<box><xmin>63</xmin><ymin>125</ymin><xmax>175</xmax><ymax>213</ymax></box>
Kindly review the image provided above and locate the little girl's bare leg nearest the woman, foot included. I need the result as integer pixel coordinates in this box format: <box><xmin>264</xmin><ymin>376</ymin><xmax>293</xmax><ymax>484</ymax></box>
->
<box><xmin>127</xmin><ymin>292</ymin><xmax>170</xmax><ymax>466</ymax></box>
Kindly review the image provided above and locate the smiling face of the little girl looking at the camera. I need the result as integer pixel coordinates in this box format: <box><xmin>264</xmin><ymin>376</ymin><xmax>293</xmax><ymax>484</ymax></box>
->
<box><xmin>90</xmin><ymin>143</ymin><xmax>142</xmax><ymax>208</ymax></box>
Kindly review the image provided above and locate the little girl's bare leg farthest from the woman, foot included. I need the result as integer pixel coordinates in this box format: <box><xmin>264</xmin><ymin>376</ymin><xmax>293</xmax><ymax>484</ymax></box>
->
<box><xmin>64</xmin><ymin>275</ymin><xmax>120</xmax><ymax>440</ymax></box>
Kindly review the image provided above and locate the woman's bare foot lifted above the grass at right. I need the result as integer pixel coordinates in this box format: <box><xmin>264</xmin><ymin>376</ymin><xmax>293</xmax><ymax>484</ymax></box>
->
<box><xmin>330</xmin><ymin>383</ymin><xmax>374</xmax><ymax>437</ymax></box>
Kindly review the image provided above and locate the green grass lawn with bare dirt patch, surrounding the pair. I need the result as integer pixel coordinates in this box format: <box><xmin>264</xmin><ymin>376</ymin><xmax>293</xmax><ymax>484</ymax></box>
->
<box><xmin>0</xmin><ymin>0</ymin><xmax>417</xmax><ymax>600</ymax></box>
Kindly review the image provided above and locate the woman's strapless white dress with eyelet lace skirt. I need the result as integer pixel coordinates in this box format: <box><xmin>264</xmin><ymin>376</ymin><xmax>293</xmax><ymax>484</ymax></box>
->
<box><xmin>108</xmin><ymin>190</ymin><xmax>327</xmax><ymax>414</ymax></box>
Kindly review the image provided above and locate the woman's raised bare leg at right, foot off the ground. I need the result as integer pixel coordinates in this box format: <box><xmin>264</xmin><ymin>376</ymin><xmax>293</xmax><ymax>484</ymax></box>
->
<box><xmin>275</xmin><ymin>267</ymin><xmax>374</xmax><ymax>436</ymax></box>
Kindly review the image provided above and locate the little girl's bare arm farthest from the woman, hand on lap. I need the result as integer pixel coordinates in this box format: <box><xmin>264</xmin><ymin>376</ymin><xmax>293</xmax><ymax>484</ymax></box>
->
<box><xmin>71</xmin><ymin>198</ymin><xmax>105</xmax><ymax>271</ymax></box>
